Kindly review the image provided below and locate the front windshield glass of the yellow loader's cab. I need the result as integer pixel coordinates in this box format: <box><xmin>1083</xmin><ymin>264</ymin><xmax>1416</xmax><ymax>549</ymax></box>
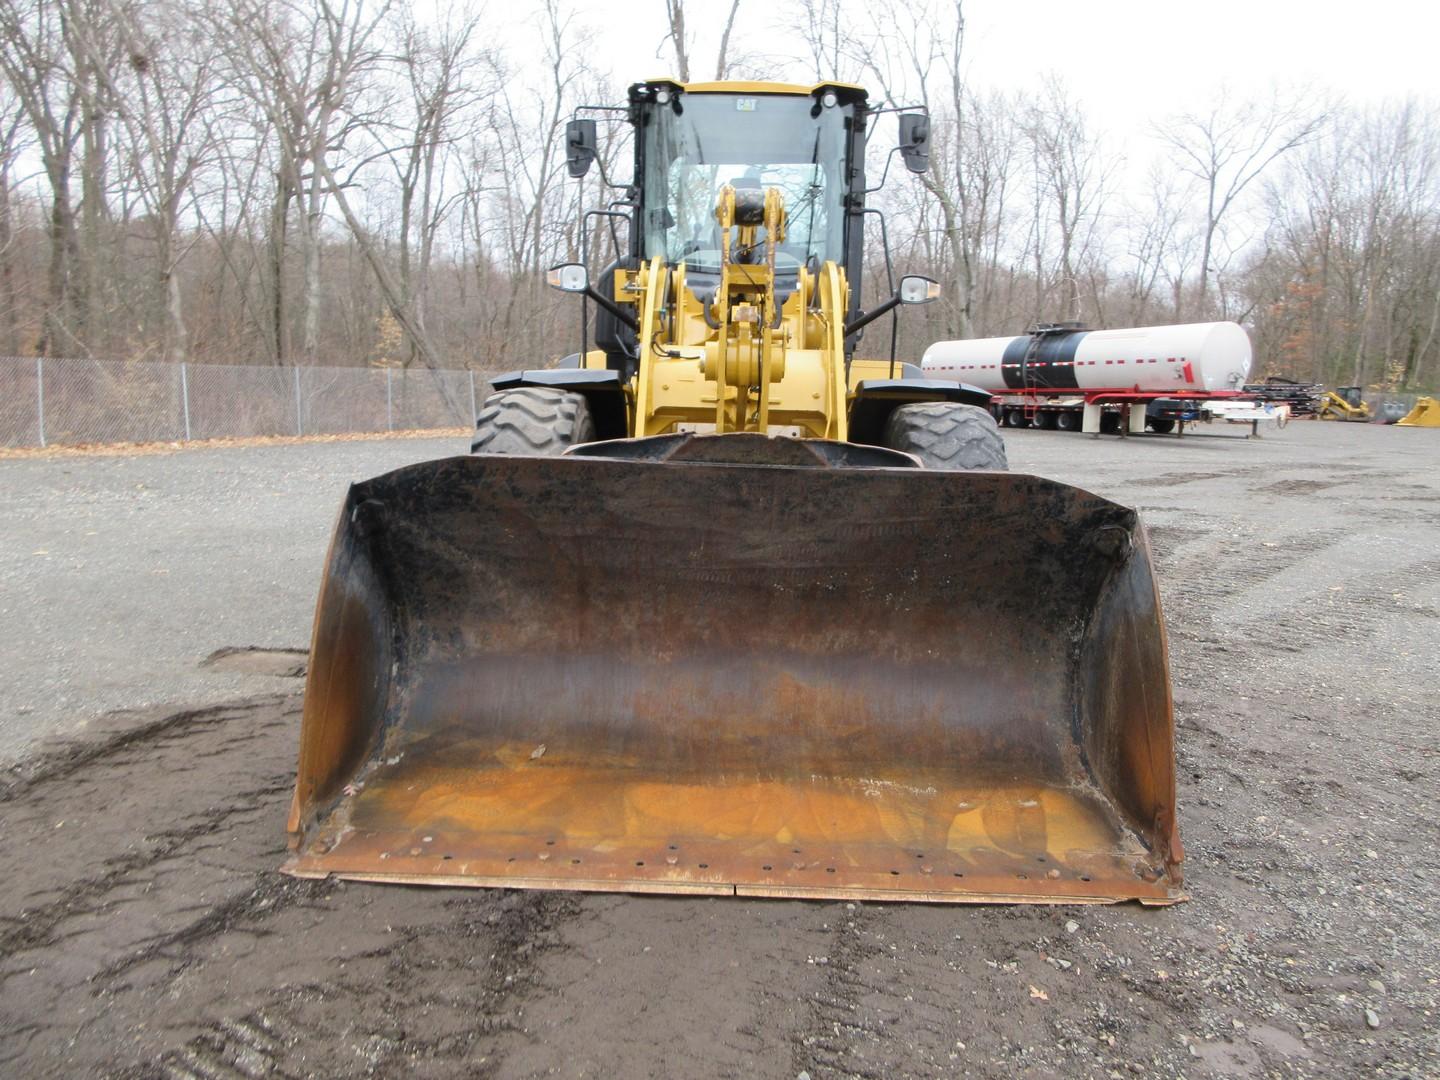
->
<box><xmin>644</xmin><ymin>94</ymin><xmax>851</xmax><ymax>271</ymax></box>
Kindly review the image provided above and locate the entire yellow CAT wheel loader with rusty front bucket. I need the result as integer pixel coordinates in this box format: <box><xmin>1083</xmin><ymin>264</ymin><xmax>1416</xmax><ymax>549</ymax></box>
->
<box><xmin>285</xmin><ymin>79</ymin><xmax>1182</xmax><ymax>904</ymax></box>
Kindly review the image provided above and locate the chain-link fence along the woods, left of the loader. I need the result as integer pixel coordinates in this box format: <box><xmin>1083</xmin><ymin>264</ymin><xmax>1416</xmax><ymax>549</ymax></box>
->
<box><xmin>0</xmin><ymin>357</ymin><xmax>506</xmax><ymax>448</ymax></box>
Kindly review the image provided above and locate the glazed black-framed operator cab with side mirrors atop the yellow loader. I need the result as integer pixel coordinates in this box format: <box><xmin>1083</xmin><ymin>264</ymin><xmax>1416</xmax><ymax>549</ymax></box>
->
<box><xmin>566</xmin><ymin>79</ymin><xmax>929</xmax><ymax>377</ymax></box>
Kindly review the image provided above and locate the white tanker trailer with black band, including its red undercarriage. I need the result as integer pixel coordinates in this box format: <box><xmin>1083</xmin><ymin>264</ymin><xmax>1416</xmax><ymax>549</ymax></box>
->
<box><xmin>920</xmin><ymin>323</ymin><xmax>1251</xmax><ymax>431</ymax></box>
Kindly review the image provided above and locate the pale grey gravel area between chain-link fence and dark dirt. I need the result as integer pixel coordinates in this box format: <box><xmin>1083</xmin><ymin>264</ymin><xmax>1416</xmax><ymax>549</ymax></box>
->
<box><xmin>0</xmin><ymin>438</ymin><xmax>467</xmax><ymax>766</ymax></box>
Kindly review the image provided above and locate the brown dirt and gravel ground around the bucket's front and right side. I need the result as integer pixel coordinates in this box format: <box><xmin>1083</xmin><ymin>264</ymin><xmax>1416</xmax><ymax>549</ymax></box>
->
<box><xmin>0</xmin><ymin>423</ymin><xmax>1440</xmax><ymax>1080</ymax></box>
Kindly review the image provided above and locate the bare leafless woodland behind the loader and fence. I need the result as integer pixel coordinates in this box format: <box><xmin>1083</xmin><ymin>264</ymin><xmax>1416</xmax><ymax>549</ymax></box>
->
<box><xmin>0</xmin><ymin>0</ymin><xmax>1440</xmax><ymax>389</ymax></box>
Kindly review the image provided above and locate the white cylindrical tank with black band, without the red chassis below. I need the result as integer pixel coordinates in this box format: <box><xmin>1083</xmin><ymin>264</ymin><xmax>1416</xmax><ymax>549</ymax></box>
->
<box><xmin>920</xmin><ymin>323</ymin><xmax>1251</xmax><ymax>395</ymax></box>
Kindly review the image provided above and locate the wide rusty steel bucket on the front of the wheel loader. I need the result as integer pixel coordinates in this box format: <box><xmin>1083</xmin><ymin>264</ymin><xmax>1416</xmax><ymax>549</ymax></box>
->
<box><xmin>285</xmin><ymin>435</ymin><xmax>1182</xmax><ymax>904</ymax></box>
